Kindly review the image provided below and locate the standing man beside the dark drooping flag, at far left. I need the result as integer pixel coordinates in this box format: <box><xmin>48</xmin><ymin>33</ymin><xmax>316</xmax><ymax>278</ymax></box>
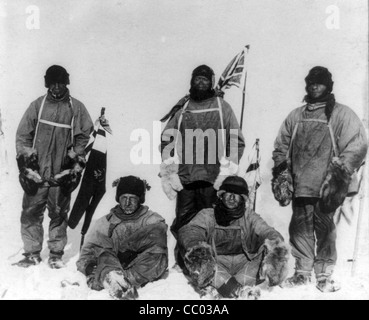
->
<box><xmin>16</xmin><ymin>65</ymin><xmax>93</xmax><ymax>269</ymax></box>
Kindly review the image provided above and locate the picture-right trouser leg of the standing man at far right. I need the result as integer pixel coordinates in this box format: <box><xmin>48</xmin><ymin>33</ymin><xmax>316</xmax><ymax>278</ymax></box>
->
<box><xmin>314</xmin><ymin>205</ymin><xmax>337</xmax><ymax>275</ymax></box>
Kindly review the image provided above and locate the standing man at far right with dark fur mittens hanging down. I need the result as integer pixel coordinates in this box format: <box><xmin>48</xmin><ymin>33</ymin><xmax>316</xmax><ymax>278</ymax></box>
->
<box><xmin>272</xmin><ymin>67</ymin><xmax>368</xmax><ymax>292</ymax></box>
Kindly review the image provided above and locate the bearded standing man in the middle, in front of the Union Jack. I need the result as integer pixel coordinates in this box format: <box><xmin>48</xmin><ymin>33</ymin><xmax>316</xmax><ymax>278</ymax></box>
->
<box><xmin>161</xmin><ymin>65</ymin><xmax>245</xmax><ymax>265</ymax></box>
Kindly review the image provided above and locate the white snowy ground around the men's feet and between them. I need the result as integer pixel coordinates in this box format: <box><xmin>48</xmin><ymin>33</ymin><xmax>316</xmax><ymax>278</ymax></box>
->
<box><xmin>0</xmin><ymin>155</ymin><xmax>369</xmax><ymax>300</ymax></box>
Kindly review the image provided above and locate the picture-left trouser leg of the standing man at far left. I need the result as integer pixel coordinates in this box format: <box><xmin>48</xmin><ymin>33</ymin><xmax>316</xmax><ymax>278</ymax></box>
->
<box><xmin>21</xmin><ymin>188</ymin><xmax>49</xmax><ymax>254</ymax></box>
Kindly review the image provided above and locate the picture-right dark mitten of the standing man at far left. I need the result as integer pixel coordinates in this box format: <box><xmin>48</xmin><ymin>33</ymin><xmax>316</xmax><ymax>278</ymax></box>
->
<box><xmin>54</xmin><ymin>150</ymin><xmax>86</xmax><ymax>194</ymax></box>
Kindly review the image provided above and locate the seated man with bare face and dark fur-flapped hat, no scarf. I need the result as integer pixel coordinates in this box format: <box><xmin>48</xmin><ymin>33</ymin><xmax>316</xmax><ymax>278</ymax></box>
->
<box><xmin>77</xmin><ymin>176</ymin><xmax>168</xmax><ymax>300</ymax></box>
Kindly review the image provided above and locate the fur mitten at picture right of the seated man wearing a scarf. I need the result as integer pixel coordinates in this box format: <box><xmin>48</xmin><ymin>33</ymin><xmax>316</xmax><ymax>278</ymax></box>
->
<box><xmin>260</xmin><ymin>239</ymin><xmax>289</xmax><ymax>287</ymax></box>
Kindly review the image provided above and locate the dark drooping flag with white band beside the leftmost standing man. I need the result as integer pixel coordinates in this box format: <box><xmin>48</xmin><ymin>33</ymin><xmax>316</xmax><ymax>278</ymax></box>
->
<box><xmin>68</xmin><ymin>108</ymin><xmax>112</xmax><ymax>246</ymax></box>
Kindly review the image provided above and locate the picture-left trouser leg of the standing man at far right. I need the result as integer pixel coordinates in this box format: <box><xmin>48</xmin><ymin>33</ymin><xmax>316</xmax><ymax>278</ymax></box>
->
<box><xmin>289</xmin><ymin>198</ymin><xmax>316</xmax><ymax>272</ymax></box>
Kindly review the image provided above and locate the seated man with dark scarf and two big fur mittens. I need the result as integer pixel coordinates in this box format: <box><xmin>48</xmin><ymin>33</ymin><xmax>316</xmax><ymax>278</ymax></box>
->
<box><xmin>179</xmin><ymin>176</ymin><xmax>289</xmax><ymax>299</ymax></box>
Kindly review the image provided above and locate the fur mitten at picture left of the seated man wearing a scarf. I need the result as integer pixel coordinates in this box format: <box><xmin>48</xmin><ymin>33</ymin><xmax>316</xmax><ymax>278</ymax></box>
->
<box><xmin>184</xmin><ymin>242</ymin><xmax>216</xmax><ymax>289</ymax></box>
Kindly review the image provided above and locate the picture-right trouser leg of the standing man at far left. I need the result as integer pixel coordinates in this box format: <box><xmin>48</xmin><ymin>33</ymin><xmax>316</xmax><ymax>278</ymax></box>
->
<box><xmin>47</xmin><ymin>187</ymin><xmax>71</xmax><ymax>256</ymax></box>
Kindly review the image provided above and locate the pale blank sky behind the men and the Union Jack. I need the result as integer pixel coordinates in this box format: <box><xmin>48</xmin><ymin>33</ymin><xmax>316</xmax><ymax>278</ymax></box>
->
<box><xmin>0</xmin><ymin>0</ymin><xmax>368</xmax><ymax>300</ymax></box>
